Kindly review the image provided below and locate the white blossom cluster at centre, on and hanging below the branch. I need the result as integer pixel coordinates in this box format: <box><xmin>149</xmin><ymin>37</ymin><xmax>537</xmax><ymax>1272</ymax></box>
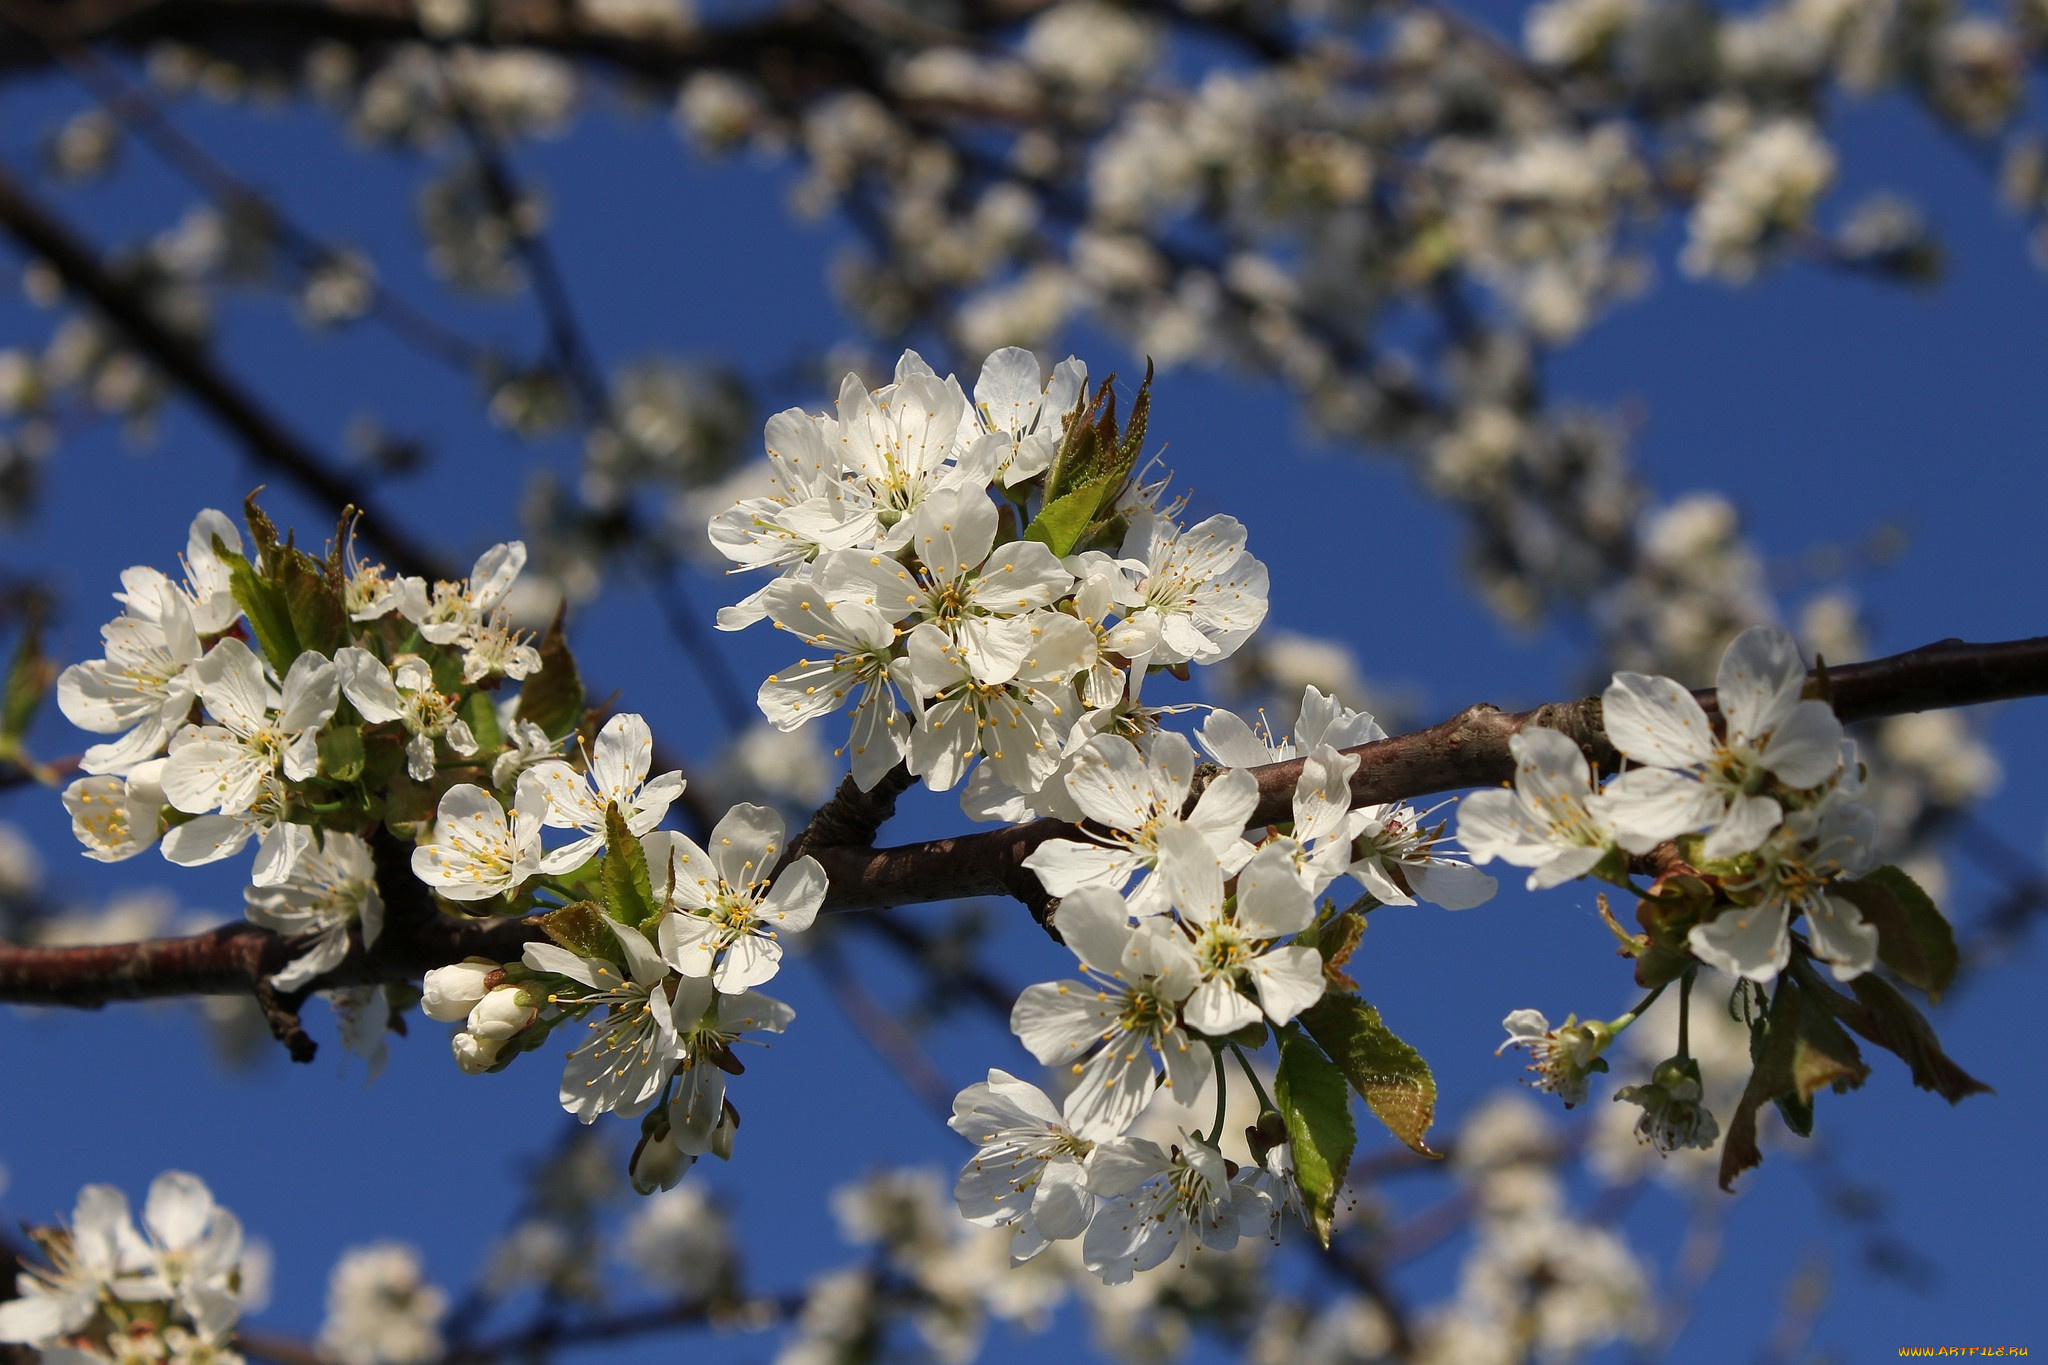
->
<box><xmin>952</xmin><ymin>688</ymin><xmax>1493</xmax><ymax>1283</ymax></box>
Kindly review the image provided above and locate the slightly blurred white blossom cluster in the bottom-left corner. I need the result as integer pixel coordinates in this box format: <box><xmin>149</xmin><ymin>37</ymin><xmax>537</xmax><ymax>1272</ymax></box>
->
<box><xmin>0</xmin><ymin>1171</ymin><xmax>268</xmax><ymax>1365</ymax></box>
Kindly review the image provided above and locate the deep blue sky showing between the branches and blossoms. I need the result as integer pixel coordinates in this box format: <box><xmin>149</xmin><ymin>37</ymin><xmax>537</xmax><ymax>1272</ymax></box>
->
<box><xmin>0</xmin><ymin>26</ymin><xmax>2048</xmax><ymax>1361</ymax></box>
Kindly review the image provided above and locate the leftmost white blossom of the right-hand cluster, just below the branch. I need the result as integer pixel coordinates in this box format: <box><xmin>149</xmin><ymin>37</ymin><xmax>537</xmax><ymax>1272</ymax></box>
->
<box><xmin>1458</xmin><ymin>724</ymin><xmax>1614</xmax><ymax>890</ymax></box>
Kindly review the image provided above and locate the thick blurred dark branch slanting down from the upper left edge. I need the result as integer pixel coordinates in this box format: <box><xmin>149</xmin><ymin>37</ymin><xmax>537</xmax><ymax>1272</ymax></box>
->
<box><xmin>0</xmin><ymin>166</ymin><xmax>457</xmax><ymax>579</ymax></box>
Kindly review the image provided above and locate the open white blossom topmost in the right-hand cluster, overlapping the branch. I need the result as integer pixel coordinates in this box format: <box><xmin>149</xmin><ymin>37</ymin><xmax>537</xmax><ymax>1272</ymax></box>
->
<box><xmin>1602</xmin><ymin>626</ymin><xmax>1843</xmax><ymax>857</ymax></box>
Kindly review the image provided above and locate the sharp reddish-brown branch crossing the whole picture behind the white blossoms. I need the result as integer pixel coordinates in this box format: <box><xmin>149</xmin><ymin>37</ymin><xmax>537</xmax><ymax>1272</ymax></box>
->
<box><xmin>0</xmin><ymin>636</ymin><xmax>2048</xmax><ymax>1007</ymax></box>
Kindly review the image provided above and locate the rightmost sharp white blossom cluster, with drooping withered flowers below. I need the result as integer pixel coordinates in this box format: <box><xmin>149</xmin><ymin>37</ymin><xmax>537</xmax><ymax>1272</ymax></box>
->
<box><xmin>1458</xmin><ymin>626</ymin><xmax>1878</xmax><ymax>1152</ymax></box>
